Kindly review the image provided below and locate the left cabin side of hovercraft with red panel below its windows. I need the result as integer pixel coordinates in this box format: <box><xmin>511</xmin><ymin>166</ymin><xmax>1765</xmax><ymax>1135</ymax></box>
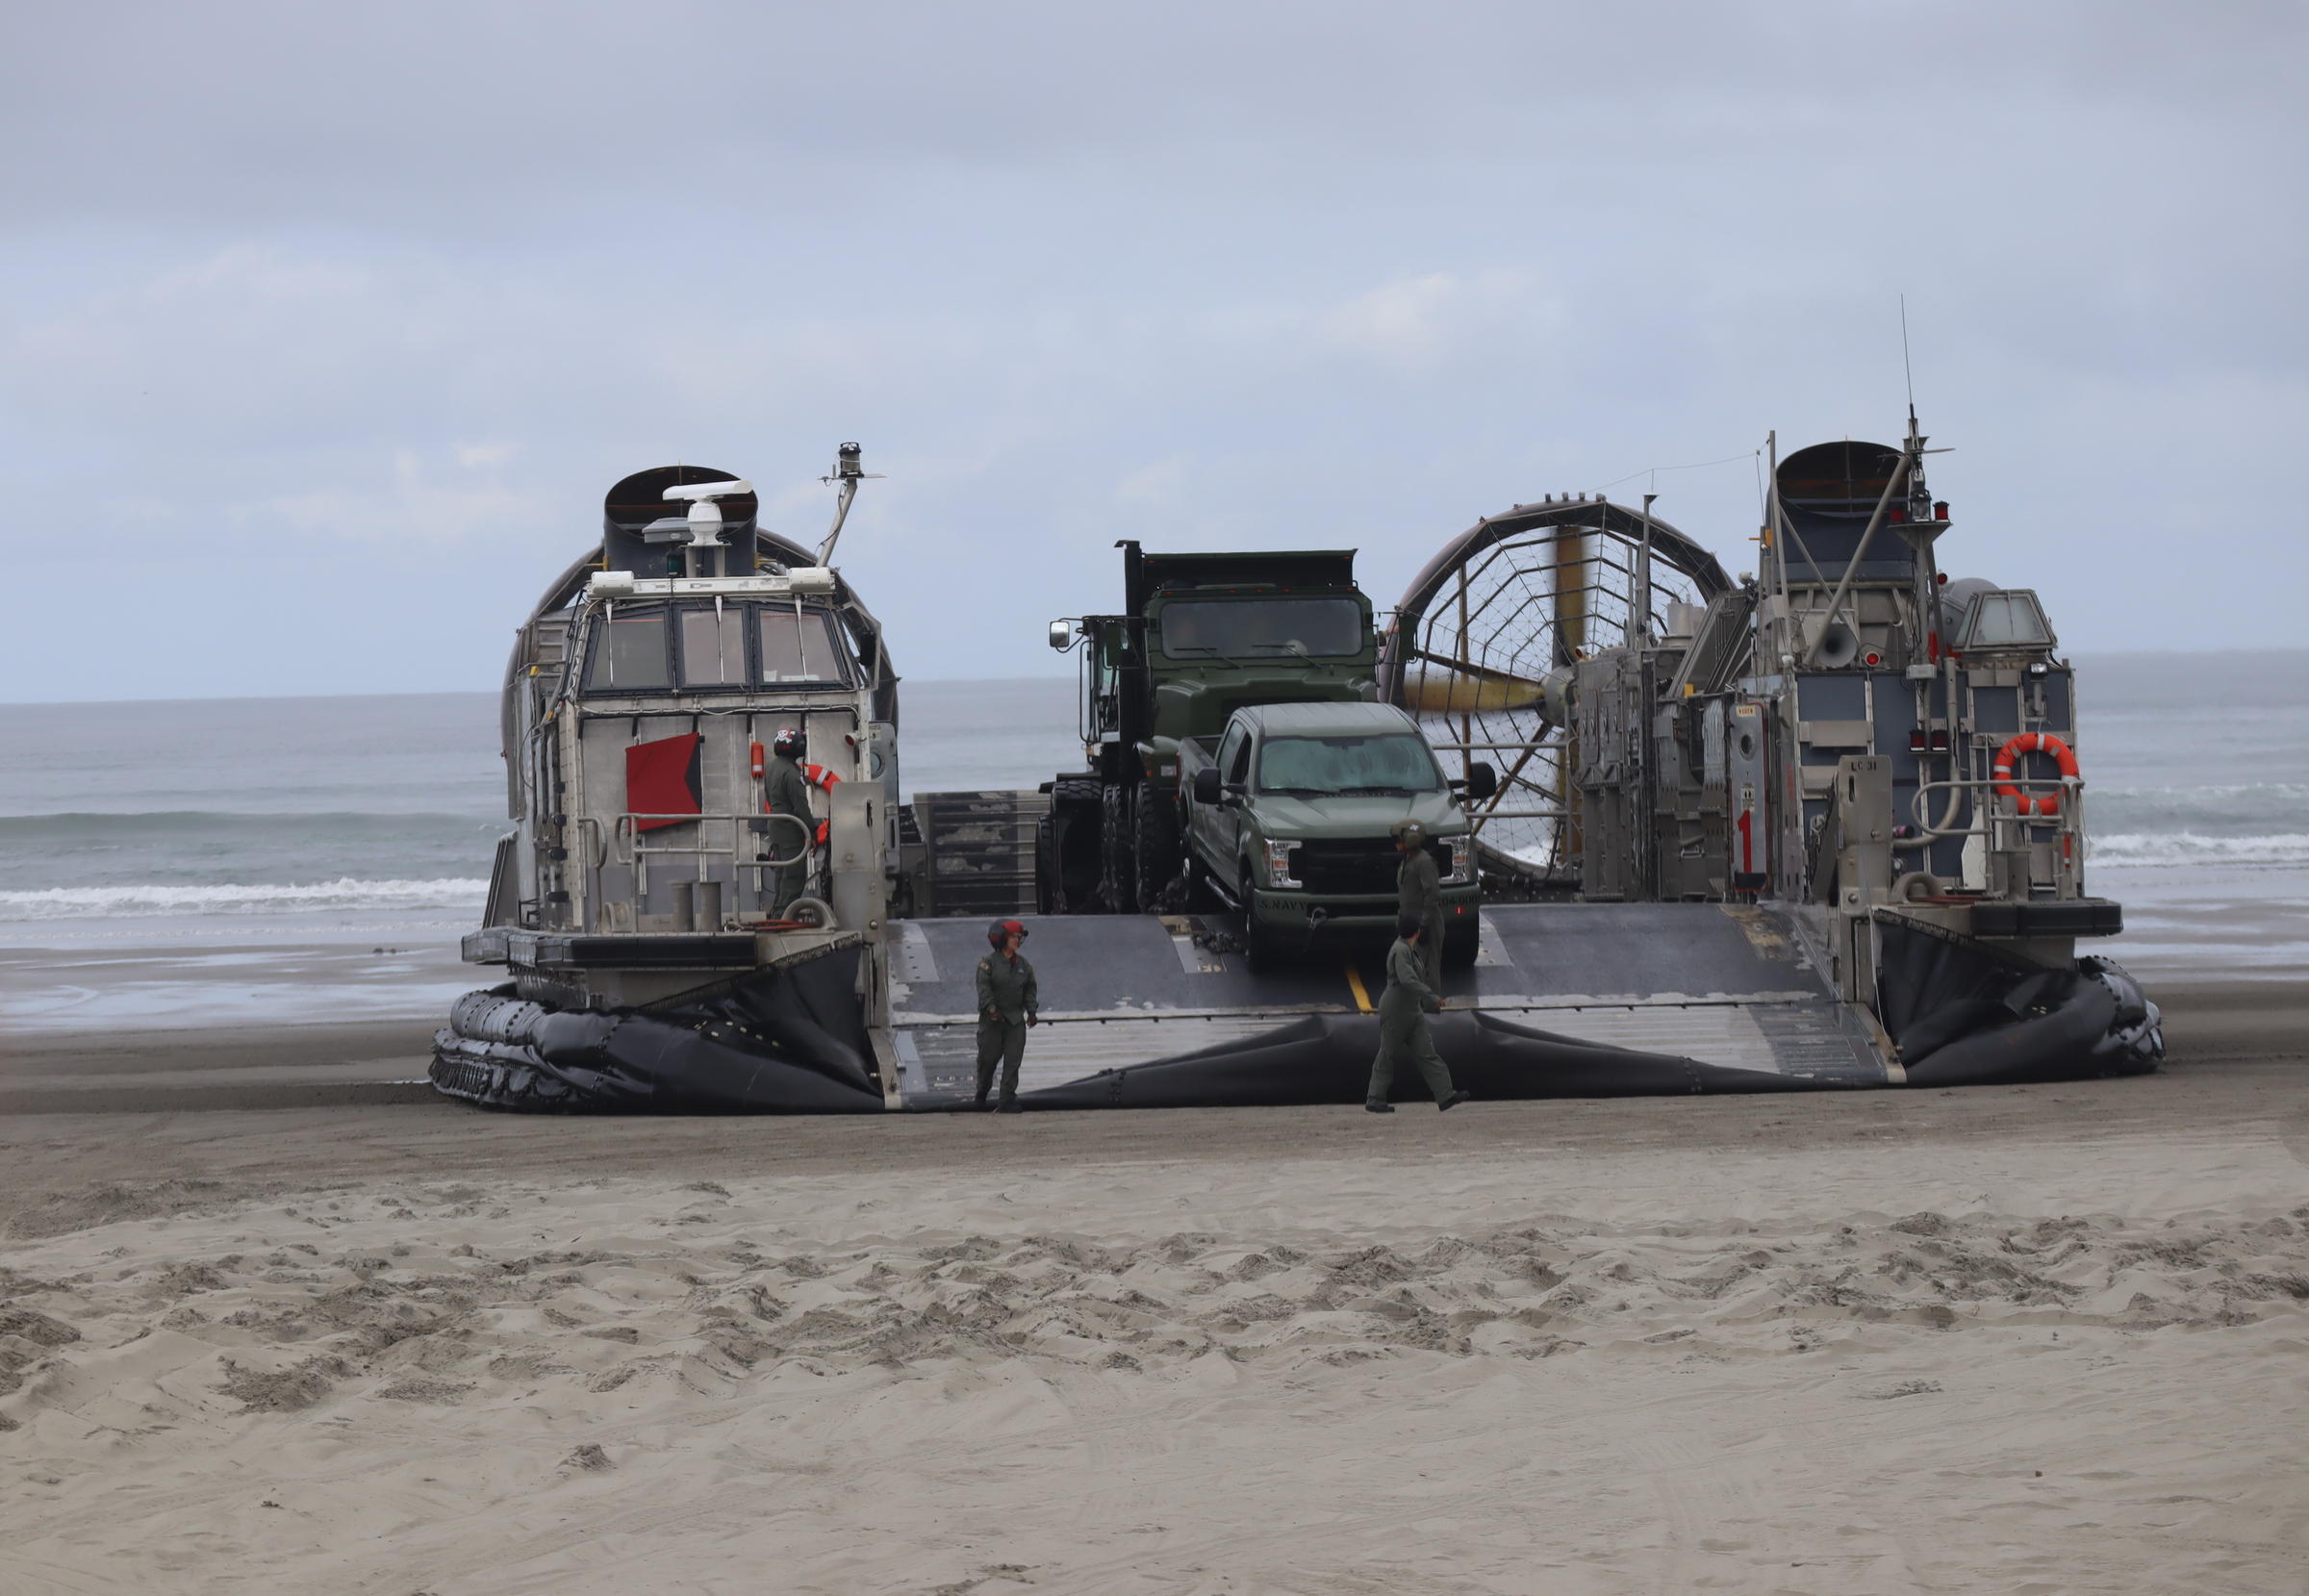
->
<box><xmin>434</xmin><ymin>445</ymin><xmax>899</xmax><ymax>1106</ymax></box>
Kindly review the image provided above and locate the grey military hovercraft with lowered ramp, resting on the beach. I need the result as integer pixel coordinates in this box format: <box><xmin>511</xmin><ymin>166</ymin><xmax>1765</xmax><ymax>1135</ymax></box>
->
<box><xmin>434</xmin><ymin>425</ymin><xmax>2161</xmax><ymax>1111</ymax></box>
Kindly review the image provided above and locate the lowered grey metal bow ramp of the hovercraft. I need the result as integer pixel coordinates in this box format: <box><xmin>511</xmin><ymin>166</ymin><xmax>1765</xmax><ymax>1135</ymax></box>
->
<box><xmin>891</xmin><ymin>903</ymin><xmax>1900</xmax><ymax>1108</ymax></box>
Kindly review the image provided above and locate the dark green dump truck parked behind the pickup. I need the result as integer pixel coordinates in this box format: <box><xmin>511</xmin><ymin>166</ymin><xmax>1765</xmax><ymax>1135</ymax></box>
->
<box><xmin>1034</xmin><ymin>543</ymin><xmax>1379</xmax><ymax>915</ymax></box>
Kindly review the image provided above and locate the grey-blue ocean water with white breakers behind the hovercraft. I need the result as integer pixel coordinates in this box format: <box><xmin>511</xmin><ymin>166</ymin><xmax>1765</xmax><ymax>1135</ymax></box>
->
<box><xmin>0</xmin><ymin>649</ymin><xmax>2309</xmax><ymax>973</ymax></box>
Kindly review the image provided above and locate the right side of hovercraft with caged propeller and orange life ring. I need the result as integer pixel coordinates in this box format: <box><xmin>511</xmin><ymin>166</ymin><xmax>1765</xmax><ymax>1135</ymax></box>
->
<box><xmin>1381</xmin><ymin>416</ymin><xmax>2164</xmax><ymax>1083</ymax></box>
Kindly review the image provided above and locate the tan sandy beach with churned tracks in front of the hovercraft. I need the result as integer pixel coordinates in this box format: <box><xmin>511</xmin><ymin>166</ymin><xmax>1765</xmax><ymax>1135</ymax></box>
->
<box><xmin>0</xmin><ymin>981</ymin><xmax>2309</xmax><ymax>1596</ymax></box>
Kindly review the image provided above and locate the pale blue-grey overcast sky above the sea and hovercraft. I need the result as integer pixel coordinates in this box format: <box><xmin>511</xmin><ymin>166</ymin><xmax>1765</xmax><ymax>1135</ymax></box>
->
<box><xmin>0</xmin><ymin>0</ymin><xmax>2309</xmax><ymax>699</ymax></box>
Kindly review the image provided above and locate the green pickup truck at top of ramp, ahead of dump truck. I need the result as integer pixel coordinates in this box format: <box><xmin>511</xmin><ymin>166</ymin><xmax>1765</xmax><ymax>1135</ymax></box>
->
<box><xmin>1178</xmin><ymin>702</ymin><xmax>1499</xmax><ymax>968</ymax></box>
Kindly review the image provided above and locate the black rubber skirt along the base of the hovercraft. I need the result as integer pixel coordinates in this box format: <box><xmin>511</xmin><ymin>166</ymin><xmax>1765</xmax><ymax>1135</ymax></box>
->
<box><xmin>432</xmin><ymin>924</ymin><xmax>2164</xmax><ymax>1113</ymax></box>
